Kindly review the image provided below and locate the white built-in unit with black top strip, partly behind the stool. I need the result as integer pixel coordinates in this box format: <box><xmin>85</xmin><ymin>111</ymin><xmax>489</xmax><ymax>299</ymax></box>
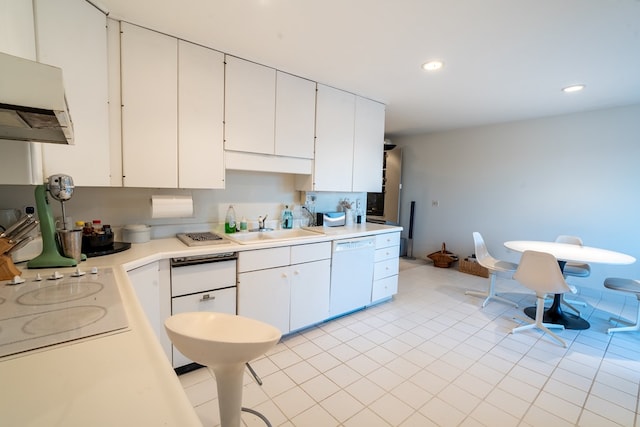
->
<box><xmin>171</xmin><ymin>252</ymin><xmax>238</xmax><ymax>373</ymax></box>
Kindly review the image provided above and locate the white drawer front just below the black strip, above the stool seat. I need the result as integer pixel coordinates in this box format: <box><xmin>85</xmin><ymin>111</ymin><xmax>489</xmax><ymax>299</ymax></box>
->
<box><xmin>171</xmin><ymin>260</ymin><xmax>236</xmax><ymax>297</ymax></box>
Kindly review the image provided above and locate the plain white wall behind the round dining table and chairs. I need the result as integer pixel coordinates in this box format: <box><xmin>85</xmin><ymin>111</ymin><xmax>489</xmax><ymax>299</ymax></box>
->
<box><xmin>393</xmin><ymin>105</ymin><xmax>640</xmax><ymax>288</ymax></box>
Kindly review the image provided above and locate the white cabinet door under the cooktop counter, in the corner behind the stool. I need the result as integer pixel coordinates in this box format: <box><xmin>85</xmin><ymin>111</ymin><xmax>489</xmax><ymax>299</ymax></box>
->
<box><xmin>127</xmin><ymin>262</ymin><xmax>171</xmax><ymax>360</ymax></box>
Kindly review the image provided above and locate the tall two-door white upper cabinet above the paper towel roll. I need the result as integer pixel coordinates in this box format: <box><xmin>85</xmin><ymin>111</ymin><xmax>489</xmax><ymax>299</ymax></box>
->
<box><xmin>120</xmin><ymin>22</ymin><xmax>225</xmax><ymax>188</ymax></box>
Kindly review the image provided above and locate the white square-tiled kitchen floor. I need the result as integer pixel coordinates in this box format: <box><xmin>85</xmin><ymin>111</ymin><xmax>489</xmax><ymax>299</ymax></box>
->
<box><xmin>180</xmin><ymin>260</ymin><xmax>640</xmax><ymax>427</ymax></box>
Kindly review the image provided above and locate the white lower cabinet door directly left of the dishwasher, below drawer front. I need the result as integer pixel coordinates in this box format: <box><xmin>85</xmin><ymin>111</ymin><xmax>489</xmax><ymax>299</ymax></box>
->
<box><xmin>289</xmin><ymin>259</ymin><xmax>331</xmax><ymax>331</ymax></box>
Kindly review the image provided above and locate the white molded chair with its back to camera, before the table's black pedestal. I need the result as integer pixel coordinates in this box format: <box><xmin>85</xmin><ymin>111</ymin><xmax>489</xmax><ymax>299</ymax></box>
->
<box><xmin>511</xmin><ymin>251</ymin><xmax>571</xmax><ymax>347</ymax></box>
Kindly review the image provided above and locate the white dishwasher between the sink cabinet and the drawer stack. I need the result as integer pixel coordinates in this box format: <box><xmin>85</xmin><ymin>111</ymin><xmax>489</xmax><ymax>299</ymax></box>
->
<box><xmin>329</xmin><ymin>237</ymin><xmax>376</xmax><ymax>317</ymax></box>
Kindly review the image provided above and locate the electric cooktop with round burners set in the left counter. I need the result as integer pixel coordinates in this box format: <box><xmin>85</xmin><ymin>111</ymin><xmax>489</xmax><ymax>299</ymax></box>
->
<box><xmin>0</xmin><ymin>268</ymin><xmax>128</xmax><ymax>357</ymax></box>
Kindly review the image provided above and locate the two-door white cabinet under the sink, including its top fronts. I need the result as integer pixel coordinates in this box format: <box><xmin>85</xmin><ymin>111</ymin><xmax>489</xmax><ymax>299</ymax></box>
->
<box><xmin>238</xmin><ymin>242</ymin><xmax>331</xmax><ymax>334</ymax></box>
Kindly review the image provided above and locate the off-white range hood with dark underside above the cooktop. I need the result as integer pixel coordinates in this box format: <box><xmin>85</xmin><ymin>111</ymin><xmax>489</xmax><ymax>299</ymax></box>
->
<box><xmin>0</xmin><ymin>52</ymin><xmax>73</xmax><ymax>144</ymax></box>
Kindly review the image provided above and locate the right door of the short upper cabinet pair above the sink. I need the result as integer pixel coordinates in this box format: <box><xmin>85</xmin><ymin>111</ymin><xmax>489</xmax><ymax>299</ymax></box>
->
<box><xmin>275</xmin><ymin>71</ymin><xmax>316</xmax><ymax>159</ymax></box>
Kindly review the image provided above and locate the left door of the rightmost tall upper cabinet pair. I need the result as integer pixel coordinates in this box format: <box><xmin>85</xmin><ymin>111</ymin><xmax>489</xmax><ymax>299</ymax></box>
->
<box><xmin>313</xmin><ymin>84</ymin><xmax>356</xmax><ymax>191</ymax></box>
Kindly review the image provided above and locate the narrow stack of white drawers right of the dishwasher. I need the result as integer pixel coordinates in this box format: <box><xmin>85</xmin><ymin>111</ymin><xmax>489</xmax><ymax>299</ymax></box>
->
<box><xmin>371</xmin><ymin>233</ymin><xmax>400</xmax><ymax>303</ymax></box>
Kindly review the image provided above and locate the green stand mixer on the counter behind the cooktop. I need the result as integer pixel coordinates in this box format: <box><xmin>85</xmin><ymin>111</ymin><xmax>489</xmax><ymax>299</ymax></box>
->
<box><xmin>27</xmin><ymin>174</ymin><xmax>78</xmax><ymax>268</ymax></box>
